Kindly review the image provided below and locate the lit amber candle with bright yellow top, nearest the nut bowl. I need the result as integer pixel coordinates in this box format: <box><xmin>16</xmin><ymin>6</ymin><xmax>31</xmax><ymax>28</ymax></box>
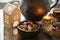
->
<box><xmin>43</xmin><ymin>15</ymin><xmax>53</xmax><ymax>31</ymax></box>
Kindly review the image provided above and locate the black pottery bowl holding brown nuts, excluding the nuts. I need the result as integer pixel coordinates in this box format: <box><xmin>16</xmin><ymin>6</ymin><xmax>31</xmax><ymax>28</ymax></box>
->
<box><xmin>17</xmin><ymin>21</ymin><xmax>40</xmax><ymax>38</ymax></box>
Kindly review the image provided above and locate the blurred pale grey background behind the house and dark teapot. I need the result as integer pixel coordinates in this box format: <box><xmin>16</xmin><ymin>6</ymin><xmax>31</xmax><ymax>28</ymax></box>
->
<box><xmin>0</xmin><ymin>0</ymin><xmax>60</xmax><ymax>9</ymax></box>
